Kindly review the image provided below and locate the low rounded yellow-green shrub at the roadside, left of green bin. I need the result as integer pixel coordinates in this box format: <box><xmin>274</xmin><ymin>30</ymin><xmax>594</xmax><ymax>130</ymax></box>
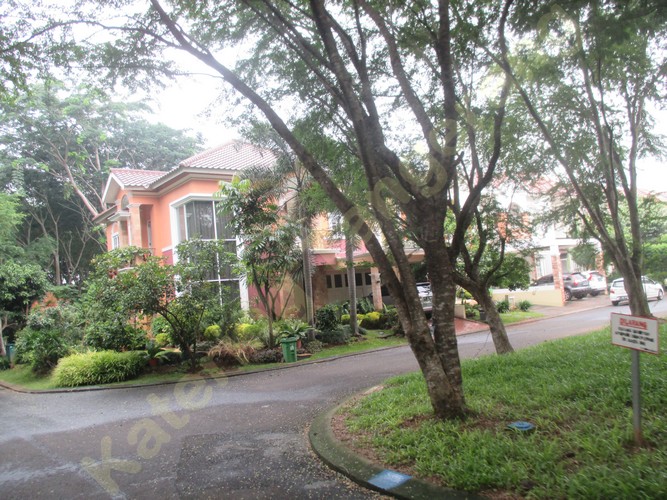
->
<box><xmin>53</xmin><ymin>351</ymin><xmax>146</xmax><ymax>387</ymax></box>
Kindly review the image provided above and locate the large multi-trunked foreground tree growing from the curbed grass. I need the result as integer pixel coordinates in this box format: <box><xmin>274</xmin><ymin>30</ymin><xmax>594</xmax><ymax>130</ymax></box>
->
<box><xmin>82</xmin><ymin>0</ymin><xmax>509</xmax><ymax>419</ymax></box>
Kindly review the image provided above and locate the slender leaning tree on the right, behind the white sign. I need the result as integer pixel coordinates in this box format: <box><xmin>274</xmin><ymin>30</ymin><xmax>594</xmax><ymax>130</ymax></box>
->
<box><xmin>498</xmin><ymin>0</ymin><xmax>667</xmax><ymax>316</ymax></box>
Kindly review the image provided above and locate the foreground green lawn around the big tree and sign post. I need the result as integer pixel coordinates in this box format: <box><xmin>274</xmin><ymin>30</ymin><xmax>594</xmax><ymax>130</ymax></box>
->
<box><xmin>346</xmin><ymin>325</ymin><xmax>667</xmax><ymax>498</ymax></box>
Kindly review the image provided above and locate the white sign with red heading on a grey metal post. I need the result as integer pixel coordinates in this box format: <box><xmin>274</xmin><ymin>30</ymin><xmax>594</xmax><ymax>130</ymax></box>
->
<box><xmin>611</xmin><ymin>313</ymin><xmax>660</xmax><ymax>445</ymax></box>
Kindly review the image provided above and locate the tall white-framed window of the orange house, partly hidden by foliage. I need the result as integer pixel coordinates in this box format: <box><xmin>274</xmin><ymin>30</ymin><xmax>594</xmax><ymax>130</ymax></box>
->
<box><xmin>178</xmin><ymin>201</ymin><xmax>240</xmax><ymax>299</ymax></box>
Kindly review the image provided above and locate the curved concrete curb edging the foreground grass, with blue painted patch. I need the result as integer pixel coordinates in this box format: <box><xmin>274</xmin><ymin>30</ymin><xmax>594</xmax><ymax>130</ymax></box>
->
<box><xmin>308</xmin><ymin>396</ymin><xmax>484</xmax><ymax>500</ymax></box>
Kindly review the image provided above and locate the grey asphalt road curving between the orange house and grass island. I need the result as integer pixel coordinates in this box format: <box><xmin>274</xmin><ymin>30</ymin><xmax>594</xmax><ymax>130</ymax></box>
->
<box><xmin>0</xmin><ymin>301</ymin><xmax>667</xmax><ymax>500</ymax></box>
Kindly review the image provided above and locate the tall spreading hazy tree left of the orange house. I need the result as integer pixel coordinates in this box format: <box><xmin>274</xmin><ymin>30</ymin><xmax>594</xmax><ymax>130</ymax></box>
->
<box><xmin>0</xmin><ymin>80</ymin><xmax>204</xmax><ymax>284</ymax></box>
